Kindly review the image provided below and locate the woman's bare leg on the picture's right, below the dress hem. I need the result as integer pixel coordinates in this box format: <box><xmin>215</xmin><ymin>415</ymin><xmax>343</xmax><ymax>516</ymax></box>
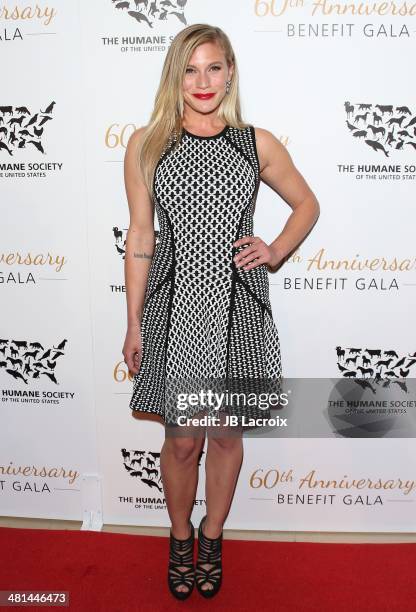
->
<box><xmin>201</xmin><ymin>418</ymin><xmax>243</xmax><ymax>590</ymax></box>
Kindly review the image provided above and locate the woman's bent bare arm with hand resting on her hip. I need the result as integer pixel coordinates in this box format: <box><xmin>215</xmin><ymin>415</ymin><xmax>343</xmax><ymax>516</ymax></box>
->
<box><xmin>233</xmin><ymin>128</ymin><xmax>320</xmax><ymax>270</ymax></box>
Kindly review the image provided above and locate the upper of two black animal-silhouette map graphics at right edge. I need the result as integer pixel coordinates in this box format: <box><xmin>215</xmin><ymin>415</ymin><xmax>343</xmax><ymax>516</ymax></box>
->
<box><xmin>344</xmin><ymin>101</ymin><xmax>416</xmax><ymax>157</ymax></box>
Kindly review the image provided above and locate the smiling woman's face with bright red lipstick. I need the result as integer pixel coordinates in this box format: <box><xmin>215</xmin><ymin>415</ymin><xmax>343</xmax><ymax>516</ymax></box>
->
<box><xmin>183</xmin><ymin>42</ymin><xmax>232</xmax><ymax>113</ymax></box>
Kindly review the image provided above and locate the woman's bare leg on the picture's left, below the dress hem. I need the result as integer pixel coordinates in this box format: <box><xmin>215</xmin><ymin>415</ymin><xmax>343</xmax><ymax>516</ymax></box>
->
<box><xmin>160</xmin><ymin>430</ymin><xmax>204</xmax><ymax>591</ymax></box>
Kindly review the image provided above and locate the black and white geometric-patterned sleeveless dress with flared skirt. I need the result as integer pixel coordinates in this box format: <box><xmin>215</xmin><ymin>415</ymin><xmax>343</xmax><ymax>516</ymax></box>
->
<box><xmin>129</xmin><ymin>125</ymin><xmax>281</xmax><ymax>427</ymax></box>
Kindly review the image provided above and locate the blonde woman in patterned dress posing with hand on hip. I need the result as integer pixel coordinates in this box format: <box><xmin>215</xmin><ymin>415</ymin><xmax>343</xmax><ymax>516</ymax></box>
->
<box><xmin>123</xmin><ymin>24</ymin><xmax>319</xmax><ymax>599</ymax></box>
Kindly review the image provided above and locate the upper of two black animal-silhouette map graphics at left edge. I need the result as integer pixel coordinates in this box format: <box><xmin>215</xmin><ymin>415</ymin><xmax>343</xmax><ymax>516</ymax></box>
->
<box><xmin>0</xmin><ymin>101</ymin><xmax>56</xmax><ymax>157</ymax></box>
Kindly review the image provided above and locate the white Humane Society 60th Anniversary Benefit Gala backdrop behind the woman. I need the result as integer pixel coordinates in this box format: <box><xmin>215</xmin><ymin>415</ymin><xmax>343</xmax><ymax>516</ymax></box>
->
<box><xmin>0</xmin><ymin>0</ymin><xmax>416</xmax><ymax>532</ymax></box>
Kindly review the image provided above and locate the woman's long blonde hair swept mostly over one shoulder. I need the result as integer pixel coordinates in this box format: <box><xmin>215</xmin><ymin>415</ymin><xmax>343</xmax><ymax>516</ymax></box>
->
<box><xmin>138</xmin><ymin>23</ymin><xmax>248</xmax><ymax>197</ymax></box>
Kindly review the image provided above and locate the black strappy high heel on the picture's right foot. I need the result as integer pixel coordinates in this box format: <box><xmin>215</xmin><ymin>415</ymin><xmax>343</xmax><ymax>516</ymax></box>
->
<box><xmin>195</xmin><ymin>515</ymin><xmax>223</xmax><ymax>597</ymax></box>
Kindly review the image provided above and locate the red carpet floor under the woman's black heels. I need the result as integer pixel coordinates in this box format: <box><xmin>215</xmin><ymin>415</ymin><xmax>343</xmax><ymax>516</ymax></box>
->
<box><xmin>0</xmin><ymin>528</ymin><xmax>416</xmax><ymax>612</ymax></box>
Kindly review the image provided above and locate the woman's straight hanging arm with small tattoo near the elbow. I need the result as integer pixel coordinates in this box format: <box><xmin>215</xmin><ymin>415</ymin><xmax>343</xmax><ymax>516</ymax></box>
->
<box><xmin>123</xmin><ymin>127</ymin><xmax>155</xmax><ymax>374</ymax></box>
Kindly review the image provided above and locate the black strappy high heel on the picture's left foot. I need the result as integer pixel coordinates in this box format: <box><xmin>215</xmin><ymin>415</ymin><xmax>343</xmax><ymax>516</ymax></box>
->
<box><xmin>168</xmin><ymin>521</ymin><xmax>195</xmax><ymax>599</ymax></box>
